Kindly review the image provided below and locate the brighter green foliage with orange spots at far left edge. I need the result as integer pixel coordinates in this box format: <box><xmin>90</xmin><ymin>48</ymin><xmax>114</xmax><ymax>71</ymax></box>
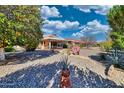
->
<box><xmin>0</xmin><ymin>13</ymin><xmax>14</xmax><ymax>48</ymax></box>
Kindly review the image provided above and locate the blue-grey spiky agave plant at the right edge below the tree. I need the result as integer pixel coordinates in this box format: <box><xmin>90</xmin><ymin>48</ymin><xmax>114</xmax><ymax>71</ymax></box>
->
<box><xmin>109</xmin><ymin>49</ymin><xmax>124</xmax><ymax>69</ymax></box>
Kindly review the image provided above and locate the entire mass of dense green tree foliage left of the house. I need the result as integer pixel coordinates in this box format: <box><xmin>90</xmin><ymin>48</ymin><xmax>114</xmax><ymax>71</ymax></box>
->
<box><xmin>0</xmin><ymin>6</ymin><xmax>42</xmax><ymax>50</ymax></box>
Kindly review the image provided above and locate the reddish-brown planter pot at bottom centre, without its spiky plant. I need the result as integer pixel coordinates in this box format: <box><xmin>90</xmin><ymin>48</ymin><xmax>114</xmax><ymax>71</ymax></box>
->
<box><xmin>60</xmin><ymin>69</ymin><xmax>71</xmax><ymax>88</ymax></box>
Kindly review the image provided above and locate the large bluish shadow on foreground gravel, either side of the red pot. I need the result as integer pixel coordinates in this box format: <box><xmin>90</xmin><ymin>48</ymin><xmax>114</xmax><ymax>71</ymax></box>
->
<box><xmin>0</xmin><ymin>62</ymin><xmax>122</xmax><ymax>88</ymax></box>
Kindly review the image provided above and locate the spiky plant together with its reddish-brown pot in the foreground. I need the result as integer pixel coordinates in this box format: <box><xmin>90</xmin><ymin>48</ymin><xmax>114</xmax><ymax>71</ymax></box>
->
<box><xmin>60</xmin><ymin>56</ymin><xmax>71</xmax><ymax>88</ymax></box>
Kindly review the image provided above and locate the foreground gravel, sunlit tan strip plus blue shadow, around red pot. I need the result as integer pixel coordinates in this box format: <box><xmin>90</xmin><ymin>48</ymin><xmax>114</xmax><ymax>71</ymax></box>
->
<box><xmin>0</xmin><ymin>50</ymin><xmax>122</xmax><ymax>88</ymax></box>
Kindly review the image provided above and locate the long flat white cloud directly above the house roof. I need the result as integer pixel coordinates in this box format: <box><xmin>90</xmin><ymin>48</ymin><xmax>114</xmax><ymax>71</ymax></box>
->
<box><xmin>43</xmin><ymin>20</ymin><xmax>79</xmax><ymax>31</ymax></box>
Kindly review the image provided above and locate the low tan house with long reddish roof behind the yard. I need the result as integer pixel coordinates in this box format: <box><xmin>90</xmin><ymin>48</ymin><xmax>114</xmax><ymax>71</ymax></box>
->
<box><xmin>38</xmin><ymin>34</ymin><xmax>97</xmax><ymax>49</ymax></box>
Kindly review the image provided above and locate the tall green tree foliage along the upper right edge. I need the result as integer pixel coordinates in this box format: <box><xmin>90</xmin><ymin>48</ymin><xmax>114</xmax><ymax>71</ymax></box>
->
<box><xmin>108</xmin><ymin>5</ymin><xmax>124</xmax><ymax>49</ymax></box>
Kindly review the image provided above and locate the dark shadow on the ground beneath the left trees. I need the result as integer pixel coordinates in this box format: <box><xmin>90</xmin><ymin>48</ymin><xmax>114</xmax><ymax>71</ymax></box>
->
<box><xmin>6</xmin><ymin>50</ymin><xmax>59</xmax><ymax>65</ymax></box>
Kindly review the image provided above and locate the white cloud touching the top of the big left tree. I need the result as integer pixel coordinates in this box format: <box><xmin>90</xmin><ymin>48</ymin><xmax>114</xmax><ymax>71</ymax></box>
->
<box><xmin>41</xmin><ymin>6</ymin><xmax>61</xmax><ymax>19</ymax></box>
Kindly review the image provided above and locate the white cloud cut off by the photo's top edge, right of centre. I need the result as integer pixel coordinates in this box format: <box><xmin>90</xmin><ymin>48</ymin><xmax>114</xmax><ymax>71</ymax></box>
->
<box><xmin>74</xmin><ymin>5</ymin><xmax>112</xmax><ymax>15</ymax></box>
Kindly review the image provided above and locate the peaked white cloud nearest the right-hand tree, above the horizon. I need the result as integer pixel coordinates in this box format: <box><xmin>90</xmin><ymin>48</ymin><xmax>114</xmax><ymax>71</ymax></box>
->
<box><xmin>72</xmin><ymin>20</ymin><xmax>110</xmax><ymax>37</ymax></box>
